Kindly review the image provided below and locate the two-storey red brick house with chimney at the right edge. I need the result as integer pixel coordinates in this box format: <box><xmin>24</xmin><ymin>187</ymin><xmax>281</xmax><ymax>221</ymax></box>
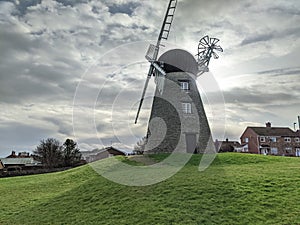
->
<box><xmin>241</xmin><ymin>123</ymin><xmax>300</xmax><ymax>156</ymax></box>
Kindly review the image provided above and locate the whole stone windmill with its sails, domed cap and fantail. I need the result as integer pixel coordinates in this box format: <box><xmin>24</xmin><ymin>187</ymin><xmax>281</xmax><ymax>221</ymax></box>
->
<box><xmin>135</xmin><ymin>0</ymin><xmax>223</xmax><ymax>153</ymax></box>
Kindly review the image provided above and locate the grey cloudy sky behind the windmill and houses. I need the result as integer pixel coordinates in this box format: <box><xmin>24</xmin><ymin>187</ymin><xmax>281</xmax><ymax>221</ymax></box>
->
<box><xmin>0</xmin><ymin>0</ymin><xmax>300</xmax><ymax>157</ymax></box>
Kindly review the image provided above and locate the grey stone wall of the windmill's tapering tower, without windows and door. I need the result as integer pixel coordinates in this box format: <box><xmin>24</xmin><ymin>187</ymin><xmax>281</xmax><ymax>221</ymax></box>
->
<box><xmin>145</xmin><ymin>72</ymin><xmax>211</xmax><ymax>153</ymax></box>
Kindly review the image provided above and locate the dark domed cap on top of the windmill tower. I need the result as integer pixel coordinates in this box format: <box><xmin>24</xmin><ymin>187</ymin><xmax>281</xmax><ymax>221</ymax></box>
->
<box><xmin>158</xmin><ymin>49</ymin><xmax>199</xmax><ymax>75</ymax></box>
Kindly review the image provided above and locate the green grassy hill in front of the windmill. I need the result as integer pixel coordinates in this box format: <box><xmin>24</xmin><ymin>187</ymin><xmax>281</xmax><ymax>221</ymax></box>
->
<box><xmin>0</xmin><ymin>153</ymin><xmax>300</xmax><ymax>225</ymax></box>
